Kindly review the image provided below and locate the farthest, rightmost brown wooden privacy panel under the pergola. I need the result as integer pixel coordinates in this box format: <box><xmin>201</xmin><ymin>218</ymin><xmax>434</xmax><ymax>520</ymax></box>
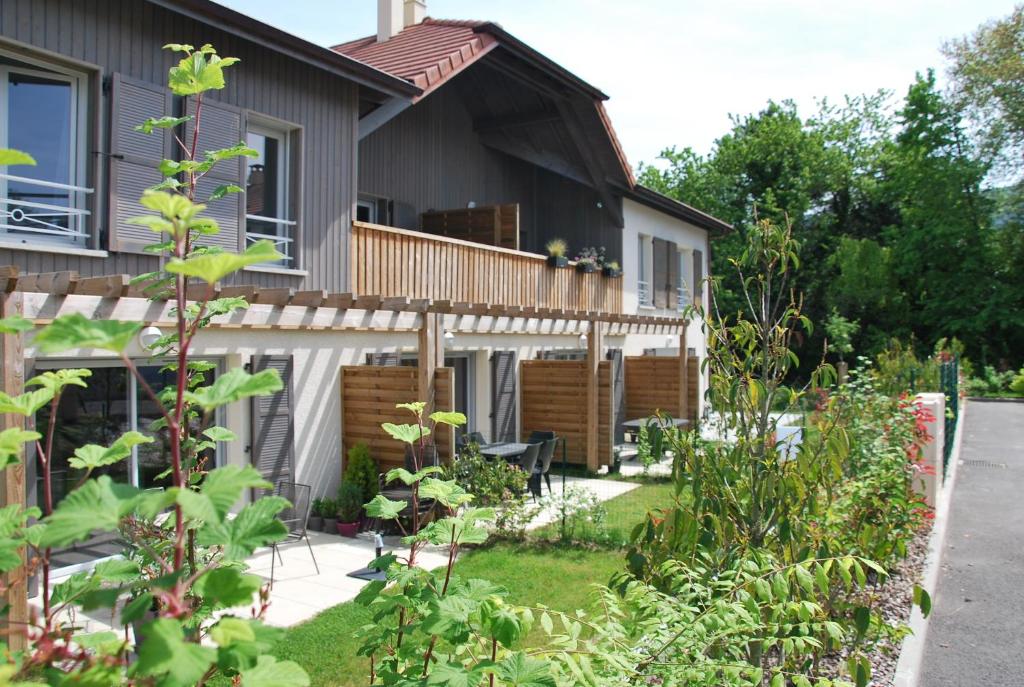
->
<box><xmin>626</xmin><ymin>355</ymin><xmax>700</xmax><ymax>420</ymax></box>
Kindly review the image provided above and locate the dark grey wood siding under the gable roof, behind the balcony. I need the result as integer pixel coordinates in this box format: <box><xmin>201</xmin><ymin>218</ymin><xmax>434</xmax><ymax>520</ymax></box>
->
<box><xmin>358</xmin><ymin>78</ymin><xmax>622</xmax><ymax>262</ymax></box>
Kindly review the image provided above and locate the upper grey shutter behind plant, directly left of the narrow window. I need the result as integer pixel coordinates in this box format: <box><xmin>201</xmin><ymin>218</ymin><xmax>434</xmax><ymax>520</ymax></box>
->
<box><xmin>184</xmin><ymin>98</ymin><xmax>247</xmax><ymax>252</ymax></box>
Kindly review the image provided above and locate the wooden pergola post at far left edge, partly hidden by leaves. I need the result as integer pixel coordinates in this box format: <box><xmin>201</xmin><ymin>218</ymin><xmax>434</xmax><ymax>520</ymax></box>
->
<box><xmin>0</xmin><ymin>292</ymin><xmax>29</xmax><ymax>650</ymax></box>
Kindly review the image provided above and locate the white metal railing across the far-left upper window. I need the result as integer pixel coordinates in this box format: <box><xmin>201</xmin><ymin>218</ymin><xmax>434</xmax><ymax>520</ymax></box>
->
<box><xmin>0</xmin><ymin>174</ymin><xmax>93</xmax><ymax>243</ymax></box>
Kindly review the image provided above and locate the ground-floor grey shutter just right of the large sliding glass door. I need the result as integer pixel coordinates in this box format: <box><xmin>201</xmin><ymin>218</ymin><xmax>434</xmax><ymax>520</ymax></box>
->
<box><xmin>252</xmin><ymin>355</ymin><xmax>296</xmax><ymax>486</ymax></box>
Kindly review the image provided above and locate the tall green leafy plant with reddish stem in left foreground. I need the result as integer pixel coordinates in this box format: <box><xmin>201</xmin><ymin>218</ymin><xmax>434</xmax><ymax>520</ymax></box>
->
<box><xmin>0</xmin><ymin>45</ymin><xmax>308</xmax><ymax>687</ymax></box>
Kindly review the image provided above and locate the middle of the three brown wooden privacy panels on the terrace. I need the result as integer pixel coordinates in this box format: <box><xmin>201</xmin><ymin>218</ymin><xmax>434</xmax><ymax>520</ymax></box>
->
<box><xmin>519</xmin><ymin>360</ymin><xmax>614</xmax><ymax>466</ymax></box>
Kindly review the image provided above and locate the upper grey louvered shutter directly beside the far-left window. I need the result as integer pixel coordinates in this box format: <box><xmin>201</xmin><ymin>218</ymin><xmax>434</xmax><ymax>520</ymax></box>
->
<box><xmin>106</xmin><ymin>74</ymin><xmax>172</xmax><ymax>253</ymax></box>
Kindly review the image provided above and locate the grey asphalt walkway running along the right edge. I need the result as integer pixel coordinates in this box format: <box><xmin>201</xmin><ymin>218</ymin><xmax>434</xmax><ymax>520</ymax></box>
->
<box><xmin>920</xmin><ymin>402</ymin><xmax>1024</xmax><ymax>687</ymax></box>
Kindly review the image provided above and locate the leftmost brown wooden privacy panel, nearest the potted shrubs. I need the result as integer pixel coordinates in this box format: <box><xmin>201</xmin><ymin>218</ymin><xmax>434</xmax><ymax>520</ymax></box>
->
<box><xmin>341</xmin><ymin>366</ymin><xmax>454</xmax><ymax>472</ymax></box>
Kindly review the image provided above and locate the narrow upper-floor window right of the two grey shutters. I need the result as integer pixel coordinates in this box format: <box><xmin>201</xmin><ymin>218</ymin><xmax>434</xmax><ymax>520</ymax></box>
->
<box><xmin>246</xmin><ymin>122</ymin><xmax>298</xmax><ymax>267</ymax></box>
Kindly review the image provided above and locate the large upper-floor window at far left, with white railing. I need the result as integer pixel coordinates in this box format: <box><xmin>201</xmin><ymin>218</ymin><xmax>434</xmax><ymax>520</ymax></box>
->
<box><xmin>0</xmin><ymin>52</ymin><xmax>92</xmax><ymax>247</ymax></box>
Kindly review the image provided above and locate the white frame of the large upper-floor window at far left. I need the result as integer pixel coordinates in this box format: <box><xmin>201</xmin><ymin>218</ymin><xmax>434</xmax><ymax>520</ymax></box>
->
<box><xmin>0</xmin><ymin>49</ymin><xmax>93</xmax><ymax>248</ymax></box>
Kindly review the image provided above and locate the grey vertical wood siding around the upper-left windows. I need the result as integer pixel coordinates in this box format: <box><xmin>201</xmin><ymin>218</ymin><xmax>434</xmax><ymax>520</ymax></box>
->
<box><xmin>0</xmin><ymin>0</ymin><xmax>357</xmax><ymax>291</ymax></box>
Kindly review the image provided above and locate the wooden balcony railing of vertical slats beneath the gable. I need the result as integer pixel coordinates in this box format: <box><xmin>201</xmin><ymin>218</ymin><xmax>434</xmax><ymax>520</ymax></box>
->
<box><xmin>349</xmin><ymin>222</ymin><xmax>623</xmax><ymax>314</ymax></box>
